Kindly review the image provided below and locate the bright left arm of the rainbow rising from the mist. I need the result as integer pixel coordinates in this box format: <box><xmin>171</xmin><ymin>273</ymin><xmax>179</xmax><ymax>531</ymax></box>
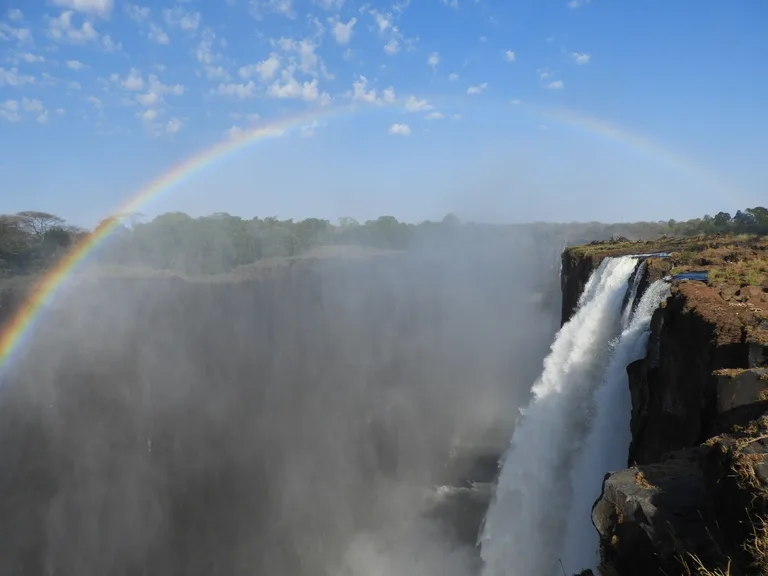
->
<box><xmin>0</xmin><ymin>107</ymin><xmax>353</xmax><ymax>375</ymax></box>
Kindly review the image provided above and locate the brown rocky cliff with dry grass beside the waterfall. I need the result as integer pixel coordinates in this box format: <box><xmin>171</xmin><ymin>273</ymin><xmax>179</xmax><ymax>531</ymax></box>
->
<box><xmin>562</xmin><ymin>236</ymin><xmax>768</xmax><ymax>576</ymax></box>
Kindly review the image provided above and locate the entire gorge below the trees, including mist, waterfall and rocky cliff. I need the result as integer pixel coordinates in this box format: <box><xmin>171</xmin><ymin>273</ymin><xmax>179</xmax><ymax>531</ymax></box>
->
<box><xmin>0</xmin><ymin>235</ymin><xmax>768</xmax><ymax>576</ymax></box>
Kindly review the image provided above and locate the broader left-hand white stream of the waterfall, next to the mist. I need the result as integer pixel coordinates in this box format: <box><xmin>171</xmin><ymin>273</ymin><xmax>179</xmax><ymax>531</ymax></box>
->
<box><xmin>480</xmin><ymin>257</ymin><xmax>637</xmax><ymax>576</ymax></box>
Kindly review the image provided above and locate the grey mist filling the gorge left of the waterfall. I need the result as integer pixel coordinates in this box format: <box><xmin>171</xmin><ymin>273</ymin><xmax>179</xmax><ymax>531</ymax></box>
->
<box><xmin>0</xmin><ymin>228</ymin><xmax>562</xmax><ymax>576</ymax></box>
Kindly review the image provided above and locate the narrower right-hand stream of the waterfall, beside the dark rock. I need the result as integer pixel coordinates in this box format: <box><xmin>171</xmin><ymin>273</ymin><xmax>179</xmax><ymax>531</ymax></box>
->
<box><xmin>562</xmin><ymin>274</ymin><xmax>669</xmax><ymax>574</ymax></box>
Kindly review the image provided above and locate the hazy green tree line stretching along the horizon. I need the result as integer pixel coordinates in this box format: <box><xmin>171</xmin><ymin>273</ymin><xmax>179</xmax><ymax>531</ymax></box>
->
<box><xmin>0</xmin><ymin>207</ymin><xmax>768</xmax><ymax>277</ymax></box>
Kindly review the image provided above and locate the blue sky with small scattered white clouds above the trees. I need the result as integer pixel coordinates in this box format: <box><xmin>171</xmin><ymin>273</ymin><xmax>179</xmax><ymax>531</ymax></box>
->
<box><xmin>0</xmin><ymin>0</ymin><xmax>768</xmax><ymax>226</ymax></box>
